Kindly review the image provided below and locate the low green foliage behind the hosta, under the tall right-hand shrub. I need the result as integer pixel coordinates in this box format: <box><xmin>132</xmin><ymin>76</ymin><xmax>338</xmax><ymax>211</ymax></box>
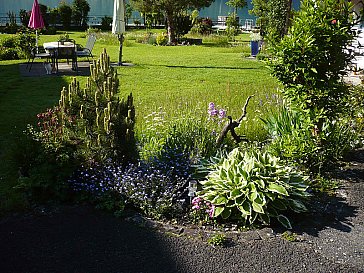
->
<box><xmin>263</xmin><ymin>107</ymin><xmax>362</xmax><ymax>172</ymax></box>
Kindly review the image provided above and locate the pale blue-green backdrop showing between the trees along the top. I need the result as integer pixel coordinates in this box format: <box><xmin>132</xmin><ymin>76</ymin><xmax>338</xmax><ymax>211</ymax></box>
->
<box><xmin>0</xmin><ymin>0</ymin><xmax>299</xmax><ymax>23</ymax></box>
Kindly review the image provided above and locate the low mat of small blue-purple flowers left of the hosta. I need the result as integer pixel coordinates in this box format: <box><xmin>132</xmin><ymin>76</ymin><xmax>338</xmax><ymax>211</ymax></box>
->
<box><xmin>68</xmin><ymin>156</ymin><xmax>188</xmax><ymax>218</ymax></box>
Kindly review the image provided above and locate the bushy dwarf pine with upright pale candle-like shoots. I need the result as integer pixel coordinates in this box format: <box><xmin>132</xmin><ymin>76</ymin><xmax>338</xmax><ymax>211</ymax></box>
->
<box><xmin>55</xmin><ymin>50</ymin><xmax>135</xmax><ymax>164</ymax></box>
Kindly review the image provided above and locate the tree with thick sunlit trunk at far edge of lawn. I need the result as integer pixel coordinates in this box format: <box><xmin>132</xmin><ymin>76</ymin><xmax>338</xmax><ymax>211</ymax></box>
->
<box><xmin>131</xmin><ymin>0</ymin><xmax>213</xmax><ymax>44</ymax></box>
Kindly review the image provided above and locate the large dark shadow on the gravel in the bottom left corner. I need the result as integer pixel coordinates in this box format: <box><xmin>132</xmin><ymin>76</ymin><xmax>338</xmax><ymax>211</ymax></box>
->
<box><xmin>0</xmin><ymin>207</ymin><xmax>182</xmax><ymax>273</ymax></box>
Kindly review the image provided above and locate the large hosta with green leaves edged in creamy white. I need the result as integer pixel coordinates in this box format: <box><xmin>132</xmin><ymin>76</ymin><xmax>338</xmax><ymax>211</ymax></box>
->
<box><xmin>198</xmin><ymin>148</ymin><xmax>309</xmax><ymax>228</ymax></box>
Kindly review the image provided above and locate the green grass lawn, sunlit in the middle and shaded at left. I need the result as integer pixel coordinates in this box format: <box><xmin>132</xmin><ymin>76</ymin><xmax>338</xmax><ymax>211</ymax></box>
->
<box><xmin>0</xmin><ymin>29</ymin><xmax>277</xmax><ymax>209</ymax></box>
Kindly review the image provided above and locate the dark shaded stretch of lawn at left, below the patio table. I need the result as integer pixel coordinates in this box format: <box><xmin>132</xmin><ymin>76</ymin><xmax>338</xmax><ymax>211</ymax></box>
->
<box><xmin>0</xmin><ymin>60</ymin><xmax>75</xmax><ymax>210</ymax></box>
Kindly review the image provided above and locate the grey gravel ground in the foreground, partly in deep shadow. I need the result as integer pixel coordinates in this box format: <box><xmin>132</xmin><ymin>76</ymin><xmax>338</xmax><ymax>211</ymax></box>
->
<box><xmin>0</xmin><ymin>151</ymin><xmax>364</xmax><ymax>273</ymax></box>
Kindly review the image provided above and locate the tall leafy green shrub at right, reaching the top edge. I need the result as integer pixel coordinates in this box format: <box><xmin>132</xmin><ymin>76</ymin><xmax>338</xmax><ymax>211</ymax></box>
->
<box><xmin>270</xmin><ymin>0</ymin><xmax>355</xmax><ymax>122</ymax></box>
